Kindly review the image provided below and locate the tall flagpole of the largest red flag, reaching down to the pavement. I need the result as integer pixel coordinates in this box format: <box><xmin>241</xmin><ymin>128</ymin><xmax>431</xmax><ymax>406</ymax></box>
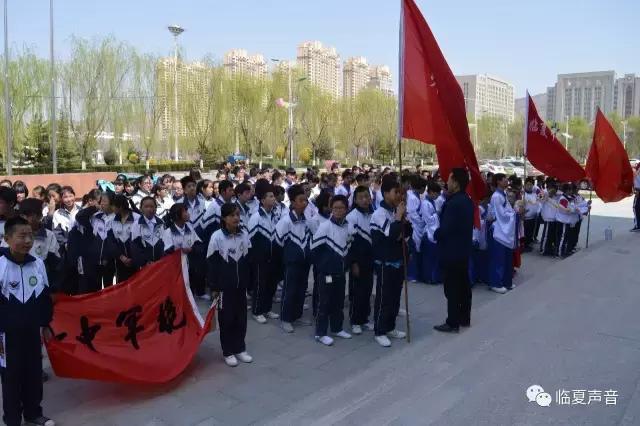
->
<box><xmin>397</xmin><ymin>0</ymin><xmax>411</xmax><ymax>343</ymax></box>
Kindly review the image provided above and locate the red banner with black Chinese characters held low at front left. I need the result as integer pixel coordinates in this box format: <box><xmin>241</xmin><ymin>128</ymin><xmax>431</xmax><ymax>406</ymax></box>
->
<box><xmin>47</xmin><ymin>252</ymin><xmax>214</xmax><ymax>383</ymax></box>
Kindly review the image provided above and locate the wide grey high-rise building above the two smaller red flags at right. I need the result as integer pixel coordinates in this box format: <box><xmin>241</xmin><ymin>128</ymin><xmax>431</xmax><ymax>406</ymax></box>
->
<box><xmin>547</xmin><ymin>71</ymin><xmax>616</xmax><ymax>122</ymax></box>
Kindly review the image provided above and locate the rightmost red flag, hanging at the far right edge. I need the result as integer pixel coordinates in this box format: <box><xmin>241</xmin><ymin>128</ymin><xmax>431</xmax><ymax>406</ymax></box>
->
<box><xmin>585</xmin><ymin>108</ymin><xmax>633</xmax><ymax>203</ymax></box>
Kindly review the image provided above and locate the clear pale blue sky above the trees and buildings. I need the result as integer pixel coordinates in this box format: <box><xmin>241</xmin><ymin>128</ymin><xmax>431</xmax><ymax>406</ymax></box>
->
<box><xmin>9</xmin><ymin>0</ymin><xmax>640</xmax><ymax>96</ymax></box>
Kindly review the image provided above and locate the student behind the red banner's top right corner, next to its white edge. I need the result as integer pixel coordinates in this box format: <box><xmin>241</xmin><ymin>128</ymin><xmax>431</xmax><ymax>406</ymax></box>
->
<box><xmin>162</xmin><ymin>203</ymin><xmax>205</xmax><ymax>301</ymax></box>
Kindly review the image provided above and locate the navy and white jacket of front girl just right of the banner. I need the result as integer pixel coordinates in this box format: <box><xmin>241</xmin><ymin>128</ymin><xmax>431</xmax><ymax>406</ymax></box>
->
<box><xmin>207</xmin><ymin>228</ymin><xmax>251</xmax><ymax>292</ymax></box>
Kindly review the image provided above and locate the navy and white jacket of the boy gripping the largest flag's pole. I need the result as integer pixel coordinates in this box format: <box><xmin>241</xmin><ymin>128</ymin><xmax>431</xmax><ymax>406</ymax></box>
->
<box><xmin>370</xmin><ymin>201</ymin><xmax>412</xmax><ymax>268</ymax></box>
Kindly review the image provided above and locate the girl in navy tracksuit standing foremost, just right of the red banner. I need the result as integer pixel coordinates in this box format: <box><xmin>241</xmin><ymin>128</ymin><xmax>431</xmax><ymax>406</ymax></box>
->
<box><xmin>207</xmin><ymin>203</ymin><xmax>253</xmax><ymax>367</ymax></box>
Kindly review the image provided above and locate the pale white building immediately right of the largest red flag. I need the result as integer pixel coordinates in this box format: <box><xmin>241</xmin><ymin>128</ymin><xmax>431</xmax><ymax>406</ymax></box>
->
<box><xmin>456</xmin><ymin>74</ymin><xmax>515</xmax><ymax>123</ymax></box>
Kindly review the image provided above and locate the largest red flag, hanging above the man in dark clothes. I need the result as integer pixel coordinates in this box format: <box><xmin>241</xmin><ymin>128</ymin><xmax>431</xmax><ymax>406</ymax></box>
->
<box><xmin>399</xmin><ymin>0</ymin><xmax>486</xmax><ymax>205</ymax></box>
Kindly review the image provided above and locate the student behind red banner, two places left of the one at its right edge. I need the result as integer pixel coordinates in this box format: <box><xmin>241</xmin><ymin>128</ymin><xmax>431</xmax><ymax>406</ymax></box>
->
<box><xmin>107</xmin><ymin>195</ymin><xmax>140</xmax><ymax>282</ymax></box>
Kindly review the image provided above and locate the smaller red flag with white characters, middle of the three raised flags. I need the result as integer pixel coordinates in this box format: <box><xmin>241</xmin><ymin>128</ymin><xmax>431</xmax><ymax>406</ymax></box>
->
<box><xmin>524</xmin><ymin>93</ymin><xmax>585</xmax><ymax>182</ymax></box>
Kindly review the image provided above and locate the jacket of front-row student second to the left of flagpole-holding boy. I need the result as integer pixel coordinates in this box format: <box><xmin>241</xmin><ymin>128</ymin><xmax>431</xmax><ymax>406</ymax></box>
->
<box><xmin>311</xmin><ymin>217</ymin><xmax>353</xmax><ymax>275</ymax></box>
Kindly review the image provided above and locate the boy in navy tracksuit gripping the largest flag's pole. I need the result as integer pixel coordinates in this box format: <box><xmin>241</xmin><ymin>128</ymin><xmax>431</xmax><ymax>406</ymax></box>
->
<box><xmin>371</xmin><ymin>176</ymin><xmax>412</xmax><ymax>347</ymax></box>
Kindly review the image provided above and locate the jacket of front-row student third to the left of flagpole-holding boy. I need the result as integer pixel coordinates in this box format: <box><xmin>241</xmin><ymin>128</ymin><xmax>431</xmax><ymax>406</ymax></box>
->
<box><xmin>276</xmin><ymin>210</ymin><xmax>312</xmax><ymax>264</ymax></box>
